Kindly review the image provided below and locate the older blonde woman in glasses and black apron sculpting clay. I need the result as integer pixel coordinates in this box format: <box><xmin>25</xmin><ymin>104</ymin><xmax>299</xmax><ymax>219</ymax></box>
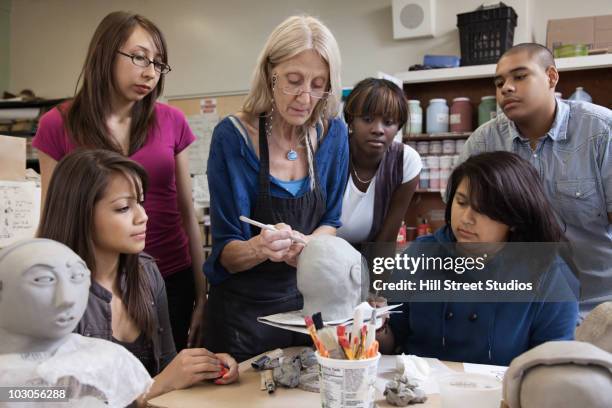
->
<box><xmin>204</xmin><ymin>16</ymin><xmax>348</xmax><ymax>361</ymax></box>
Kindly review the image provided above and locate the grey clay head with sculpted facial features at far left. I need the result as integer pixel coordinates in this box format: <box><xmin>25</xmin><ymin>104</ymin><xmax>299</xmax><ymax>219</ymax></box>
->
<box><xmin>0</xmin><ymin>239</ymin><xmax>91</xmax><ymax>340</ymax></box>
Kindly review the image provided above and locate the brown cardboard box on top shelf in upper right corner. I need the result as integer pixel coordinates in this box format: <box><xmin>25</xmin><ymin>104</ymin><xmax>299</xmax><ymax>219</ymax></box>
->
<box><xmin>546</xmin><ymin>15</ymin><xmax>612</xmax><ymax>52</ymax></box>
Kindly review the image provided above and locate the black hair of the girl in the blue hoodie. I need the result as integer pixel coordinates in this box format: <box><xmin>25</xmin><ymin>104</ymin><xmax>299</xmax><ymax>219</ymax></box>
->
<box><xmin>445</xmin><ymin>151</ymin><xmax>566</xmax><ymax>242</ymax></box>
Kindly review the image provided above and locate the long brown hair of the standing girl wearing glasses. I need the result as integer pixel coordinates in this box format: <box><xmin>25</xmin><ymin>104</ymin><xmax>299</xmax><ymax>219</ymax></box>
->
<box><xmin>60</xmin><ymin>11</ymin><xmax>168</xmax><ymax>155</ymax></box>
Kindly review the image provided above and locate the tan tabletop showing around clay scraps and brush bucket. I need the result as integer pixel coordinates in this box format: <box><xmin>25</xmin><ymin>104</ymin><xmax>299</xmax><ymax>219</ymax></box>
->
<box><xmin>148</xmin><ymin>348</ymin><xmax>463</xmax><ymax>408</ymax></box>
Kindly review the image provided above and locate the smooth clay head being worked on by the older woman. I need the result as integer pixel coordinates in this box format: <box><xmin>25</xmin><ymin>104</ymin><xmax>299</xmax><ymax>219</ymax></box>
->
<box><xmin>297</xmin><ymin>235</ymin><xmax>367</xmax><ymax>321</ymax></box>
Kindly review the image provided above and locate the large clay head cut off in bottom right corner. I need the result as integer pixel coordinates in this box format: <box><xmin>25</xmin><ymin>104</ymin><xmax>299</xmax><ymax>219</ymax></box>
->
<box><xmin>503</xmin><ymin>341</ymin><xmax>612</xmax><ymax>408</ymax></box>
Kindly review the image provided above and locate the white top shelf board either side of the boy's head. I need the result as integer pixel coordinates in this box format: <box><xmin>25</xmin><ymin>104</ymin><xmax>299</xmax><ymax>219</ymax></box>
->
<box><xmin>394</xmin><ymin>54</ymin><xmax>612</xmax><ymax>84</ymax></box>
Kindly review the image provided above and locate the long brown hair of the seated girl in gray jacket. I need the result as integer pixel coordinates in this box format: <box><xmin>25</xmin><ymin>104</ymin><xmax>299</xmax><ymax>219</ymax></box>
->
<box><xmin>37</xmin><ymin>149</ymin><xmax>153</xmax><ymax>338</ymax></box>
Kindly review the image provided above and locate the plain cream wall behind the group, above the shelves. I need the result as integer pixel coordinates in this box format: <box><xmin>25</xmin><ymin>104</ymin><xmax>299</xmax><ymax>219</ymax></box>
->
<box><xmin>10</xmin><ymin>0</ymin><xmax>612</xmax><ymax>97</ymax></box>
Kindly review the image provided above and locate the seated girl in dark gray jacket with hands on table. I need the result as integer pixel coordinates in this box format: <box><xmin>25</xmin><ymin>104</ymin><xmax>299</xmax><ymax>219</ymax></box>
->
<box><xmin>38</xmin><ymin>150</ymin><xmax>238</xmax><ymax>399</ymax></box>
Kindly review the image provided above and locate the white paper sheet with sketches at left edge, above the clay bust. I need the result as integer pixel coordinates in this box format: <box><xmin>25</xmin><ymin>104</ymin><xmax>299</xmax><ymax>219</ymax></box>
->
<box><xmin>0</xmin><ymin>181</ymin><xmax>40</xmax><ymax>248</ymax></box>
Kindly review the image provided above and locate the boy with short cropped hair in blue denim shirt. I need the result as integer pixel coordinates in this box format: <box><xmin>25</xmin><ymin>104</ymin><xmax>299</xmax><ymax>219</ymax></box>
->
<box><xmin>460</xmin><ymin>43</ymin><xmax>612</xmax><ymax>313</ymax></box>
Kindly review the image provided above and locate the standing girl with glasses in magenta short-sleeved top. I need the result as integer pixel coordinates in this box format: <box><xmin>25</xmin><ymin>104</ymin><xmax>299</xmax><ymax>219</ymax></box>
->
<box><xmin>33</xmin><ymin>12</ymin><xmax>206</xmax><ymax>351</ymax></box>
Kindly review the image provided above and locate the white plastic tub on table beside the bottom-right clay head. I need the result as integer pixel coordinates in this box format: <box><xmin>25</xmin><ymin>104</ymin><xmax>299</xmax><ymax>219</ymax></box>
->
<box><xmin>438</xmin><ymin>373</ymin><xmax>502</xmax><ymax>408</ymax></box>
